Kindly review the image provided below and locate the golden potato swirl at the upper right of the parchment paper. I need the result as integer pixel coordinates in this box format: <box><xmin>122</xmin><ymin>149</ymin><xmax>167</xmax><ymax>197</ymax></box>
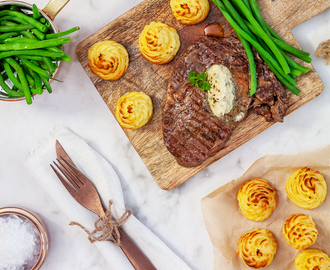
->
<box><xmin>285</xmin><ymin>167</ymin><xmax>327</xmax><ymax>209</ymax></box>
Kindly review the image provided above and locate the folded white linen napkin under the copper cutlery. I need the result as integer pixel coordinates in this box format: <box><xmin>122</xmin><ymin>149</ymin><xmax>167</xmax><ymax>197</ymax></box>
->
<box><xmin>25</xmin><ymin>127</ymin><xmax>190</xmax><ymax>270</ymax></box>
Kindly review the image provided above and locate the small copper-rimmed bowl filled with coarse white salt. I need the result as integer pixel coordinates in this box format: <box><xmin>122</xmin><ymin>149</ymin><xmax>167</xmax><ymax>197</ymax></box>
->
<box><xmin>0</xmin><ymin>207</ymin><xmax>48</xmax><ymax>270</ymax></box>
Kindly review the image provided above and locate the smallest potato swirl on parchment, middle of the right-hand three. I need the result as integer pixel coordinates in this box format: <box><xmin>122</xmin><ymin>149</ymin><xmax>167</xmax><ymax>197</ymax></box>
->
<box><xmin>283</xmin><ymin>214</ymin><xmax>319</xmax><ymax>249</ymax></box>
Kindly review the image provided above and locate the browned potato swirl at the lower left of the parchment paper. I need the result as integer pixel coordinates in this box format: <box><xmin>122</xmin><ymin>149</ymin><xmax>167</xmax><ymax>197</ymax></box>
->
<box><xmin>238</xmin><ymin>229</ymin><xmax>277</xmax><ymax>269</ymax></box>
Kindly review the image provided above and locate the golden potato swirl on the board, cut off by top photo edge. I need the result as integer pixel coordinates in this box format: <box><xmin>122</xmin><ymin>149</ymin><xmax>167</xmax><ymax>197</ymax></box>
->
<box><xmin>170</xmin><ymin>0</ymin><xmax>210</xmax><ymax>25</ymax></box>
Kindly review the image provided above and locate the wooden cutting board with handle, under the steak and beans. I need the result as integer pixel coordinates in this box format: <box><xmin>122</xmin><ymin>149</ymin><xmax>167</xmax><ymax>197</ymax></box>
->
<box><xmin>76</xmin><ymin>0</ymin><xmax>330</xmax><ymax>190</ymax></box>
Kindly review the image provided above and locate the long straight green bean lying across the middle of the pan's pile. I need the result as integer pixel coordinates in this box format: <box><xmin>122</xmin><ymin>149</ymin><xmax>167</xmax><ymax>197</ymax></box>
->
<box><xmin>0</xmin><ymin>36</ymin><xmax>70</xmax><ymax>51</ymax></box>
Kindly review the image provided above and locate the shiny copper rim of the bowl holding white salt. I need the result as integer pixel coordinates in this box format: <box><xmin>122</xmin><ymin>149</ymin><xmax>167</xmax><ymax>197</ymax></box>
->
<box><xmin>0</xmin><ymin>207</ymin><xmax>49</xmax><ymax>270</ymax></box>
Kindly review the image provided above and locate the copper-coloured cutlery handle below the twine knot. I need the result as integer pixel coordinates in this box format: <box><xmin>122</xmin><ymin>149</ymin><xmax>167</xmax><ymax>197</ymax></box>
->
<box><xmin>119</xmin><ymin>228</ymin><xmax>157</xmax><ymax>270</ymax></box>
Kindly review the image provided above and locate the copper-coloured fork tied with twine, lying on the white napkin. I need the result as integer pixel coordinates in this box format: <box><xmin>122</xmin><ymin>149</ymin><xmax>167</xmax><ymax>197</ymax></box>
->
<box><xmin>50</xmin><ymin>157</ymin><xmax>156</xmax><ymax>270</ymax></box>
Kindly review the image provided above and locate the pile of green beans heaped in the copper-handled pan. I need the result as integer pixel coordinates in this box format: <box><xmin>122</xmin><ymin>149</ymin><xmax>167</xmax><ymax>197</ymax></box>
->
<box><xmin>0</xmin><ymin>5</ymin><xmax>79</xmax><ymax>104</ymax></box>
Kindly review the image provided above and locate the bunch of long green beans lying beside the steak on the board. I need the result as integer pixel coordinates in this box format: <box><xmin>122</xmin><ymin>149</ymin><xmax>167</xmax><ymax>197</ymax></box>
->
<box><xmin>212</xmin><ymin>0</ymin><xmax>312</xmax><ymax>96</ymax></box>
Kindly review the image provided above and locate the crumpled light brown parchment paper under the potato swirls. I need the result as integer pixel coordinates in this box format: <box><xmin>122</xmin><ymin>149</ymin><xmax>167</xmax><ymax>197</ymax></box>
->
<box><xmin>202</xmin><ymin>145</ymin><xmax>330</xmax><ymax>270</ymax></box>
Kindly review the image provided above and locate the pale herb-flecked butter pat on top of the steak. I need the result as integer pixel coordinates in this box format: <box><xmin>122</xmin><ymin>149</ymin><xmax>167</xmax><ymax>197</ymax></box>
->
<box><xmin>207</xmin><ymin>65</ymin><xmax>235</xmax><ymax>117</ymax></box>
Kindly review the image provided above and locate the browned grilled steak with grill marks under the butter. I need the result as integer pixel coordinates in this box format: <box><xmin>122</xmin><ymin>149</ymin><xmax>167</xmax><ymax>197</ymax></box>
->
<box><xmin>163</xmin><ymin>36</ymin><xmax>287</xmax><ymax>167</ymax></box>
